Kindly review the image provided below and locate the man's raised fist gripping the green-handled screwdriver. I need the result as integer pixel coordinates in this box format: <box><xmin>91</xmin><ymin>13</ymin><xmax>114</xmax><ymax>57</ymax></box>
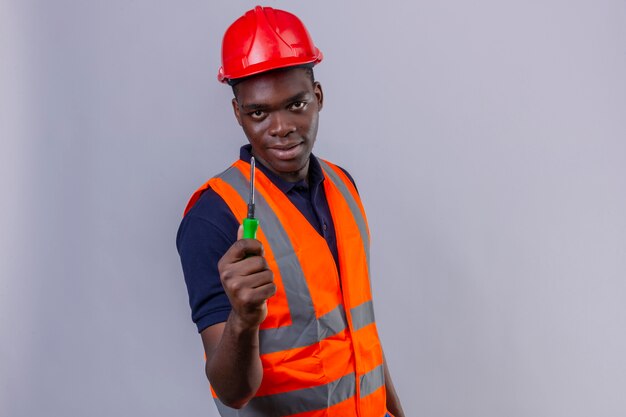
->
<box><xmin>217</xmin><ymin>226</ymin><xmax>276</xmax><ymax>328</ymax></box>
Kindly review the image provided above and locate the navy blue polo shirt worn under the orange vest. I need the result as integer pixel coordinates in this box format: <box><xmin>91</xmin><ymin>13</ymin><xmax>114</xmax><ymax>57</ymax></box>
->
<box><xmin>176</xmin><ymin>145</ymin><xmax>354</xmax><ymax>332</ymax></box>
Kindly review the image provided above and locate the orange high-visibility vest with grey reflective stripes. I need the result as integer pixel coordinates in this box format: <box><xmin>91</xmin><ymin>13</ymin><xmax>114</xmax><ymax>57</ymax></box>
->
<box><xmin>185</xmin><ymin>160</ymin><xmax>386</xmax><ymax>417</ymax></box>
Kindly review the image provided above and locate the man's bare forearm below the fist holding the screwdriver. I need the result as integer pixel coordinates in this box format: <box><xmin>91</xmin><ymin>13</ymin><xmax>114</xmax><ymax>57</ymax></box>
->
<box><xmin>206</xmin><ymin>313</ymin><xmax>263</xmax><ymax>408</ymax></box>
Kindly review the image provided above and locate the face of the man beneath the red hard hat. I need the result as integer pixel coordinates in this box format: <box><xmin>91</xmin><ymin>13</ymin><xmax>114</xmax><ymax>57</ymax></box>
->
<box><xmin>233</xmin><ymin>68</ymin><xmax>323</xmax><ymax>182</ymax></box>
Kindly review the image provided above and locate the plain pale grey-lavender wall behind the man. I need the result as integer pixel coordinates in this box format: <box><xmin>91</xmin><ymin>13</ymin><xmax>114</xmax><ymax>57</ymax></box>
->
<box><xmin>0</xmin><ymin>0</ymin><xmax>626</xmax><ymax>417</ymax></box>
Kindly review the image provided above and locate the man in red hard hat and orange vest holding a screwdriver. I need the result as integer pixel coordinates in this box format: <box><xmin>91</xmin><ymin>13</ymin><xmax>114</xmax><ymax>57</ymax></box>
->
<box><xmin>177</xmin><ymin>6</ymin><xmax>404</xmax><ymax>417</ymax></box>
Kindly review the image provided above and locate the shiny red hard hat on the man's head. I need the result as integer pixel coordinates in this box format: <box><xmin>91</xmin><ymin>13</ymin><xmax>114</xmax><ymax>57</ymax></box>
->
<box><xmin>217</xmin><ymin>6</ymin><xmax>323</xmax><ymax>82</ymax></box>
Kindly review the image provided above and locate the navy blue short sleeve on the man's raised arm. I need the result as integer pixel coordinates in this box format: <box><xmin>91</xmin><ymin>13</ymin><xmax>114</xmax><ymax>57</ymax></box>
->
<box><xmin>176</xmin><ymin>189</ymin><xmax>239</xmax><ymax>332</ymax></box>
